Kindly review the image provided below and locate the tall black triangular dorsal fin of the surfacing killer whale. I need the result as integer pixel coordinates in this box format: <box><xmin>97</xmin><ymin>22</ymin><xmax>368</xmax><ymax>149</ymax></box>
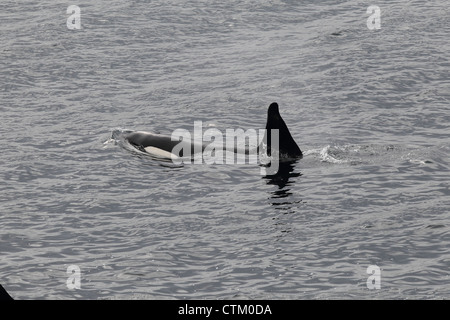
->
<box><xmin>266</xmin><ymin>102</ymin><xmax>303</xmax><ymax>158</ymax></box>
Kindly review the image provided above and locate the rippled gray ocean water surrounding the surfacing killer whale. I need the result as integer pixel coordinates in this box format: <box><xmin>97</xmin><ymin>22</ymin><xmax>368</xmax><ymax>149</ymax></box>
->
<box><xmin>0</xmin><ymin>0</ymin><xmax>450</xmax><ymax>299</ymax></box>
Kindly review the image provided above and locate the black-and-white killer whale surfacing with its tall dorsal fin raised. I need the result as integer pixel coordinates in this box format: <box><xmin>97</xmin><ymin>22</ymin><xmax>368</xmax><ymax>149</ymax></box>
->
<box><xmin>124</xmin><ymin>102</ymin><xmax>303</xmax><ymax>159</ymax></box>
